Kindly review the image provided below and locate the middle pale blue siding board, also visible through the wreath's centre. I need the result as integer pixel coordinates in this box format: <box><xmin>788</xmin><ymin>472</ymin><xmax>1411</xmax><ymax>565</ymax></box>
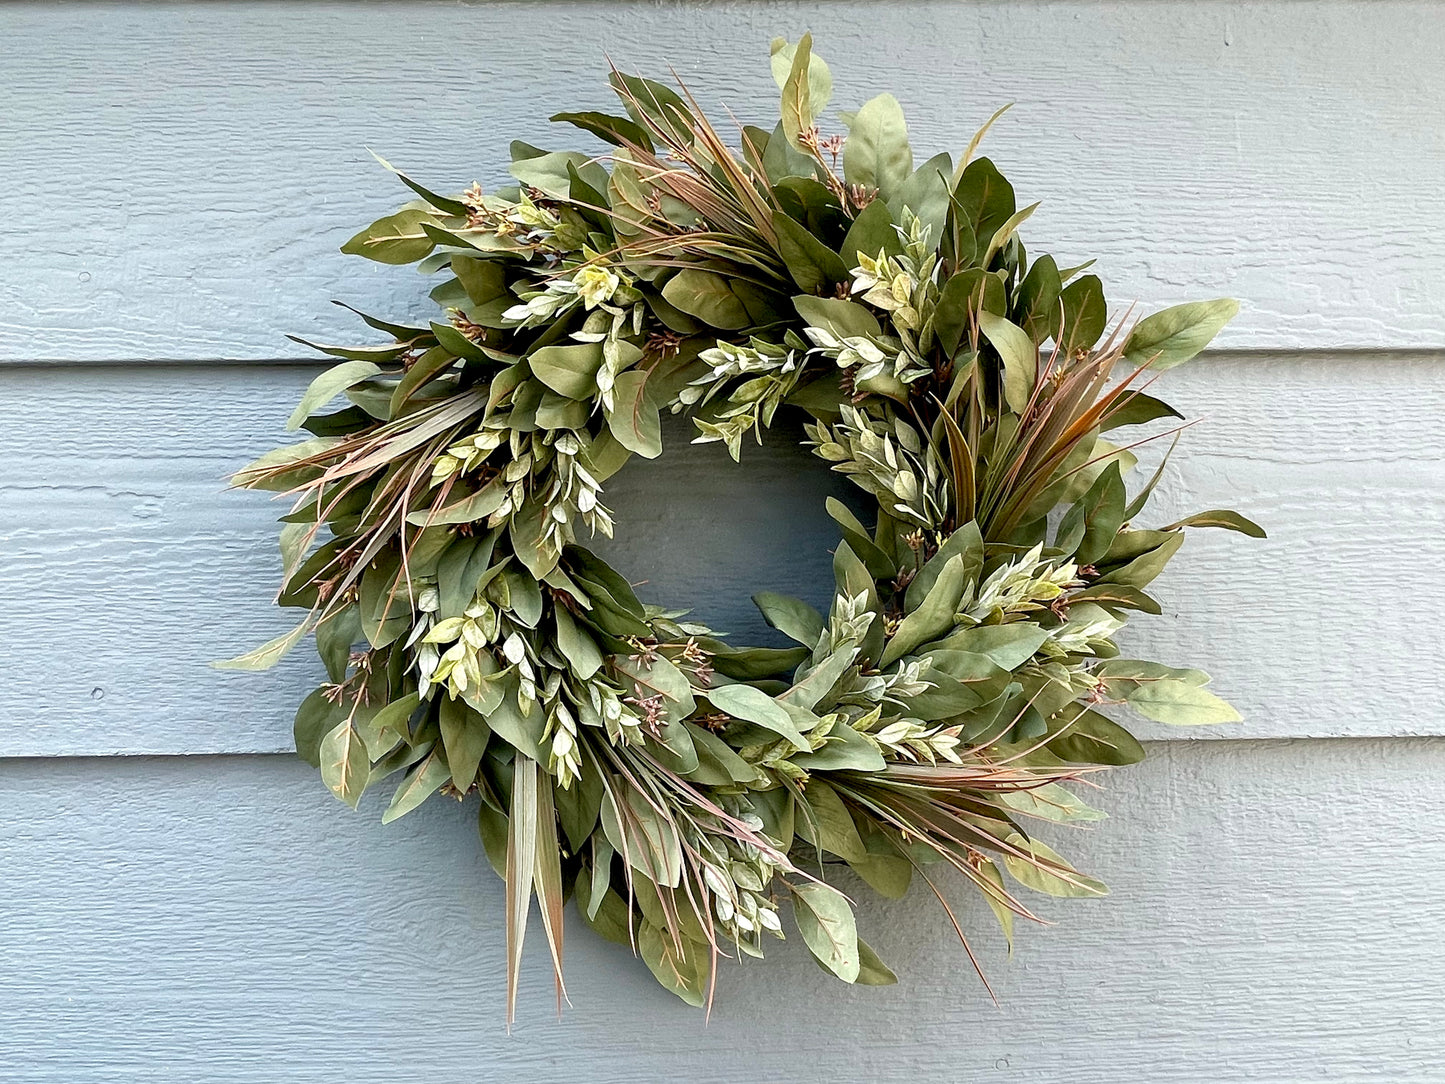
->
<box><xmin>0</xmin><ymin>356</ymin><xmax>1445</xmax><ymax>756</ymax></box>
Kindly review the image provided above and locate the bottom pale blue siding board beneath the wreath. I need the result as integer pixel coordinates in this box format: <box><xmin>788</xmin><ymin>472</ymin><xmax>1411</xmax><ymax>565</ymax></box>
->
<box><xmin>0</xmin><ymin>740</ymin><xmax>1445</xmax><ymax>1084</ymax></box>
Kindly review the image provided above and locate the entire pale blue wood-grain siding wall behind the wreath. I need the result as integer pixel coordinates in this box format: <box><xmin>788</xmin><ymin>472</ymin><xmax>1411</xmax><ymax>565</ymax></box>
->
<box><xmin>8</xmin><ymin>0</ymin><xmax>1445</xmax><ymax>1084</ymax></box>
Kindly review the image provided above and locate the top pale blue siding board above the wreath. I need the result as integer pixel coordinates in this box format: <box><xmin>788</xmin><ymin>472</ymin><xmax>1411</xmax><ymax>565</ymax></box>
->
<box><xmin>0</xmin><ymin>0</ymin><xmax>1445</xmax><ymax>360</ymax></box>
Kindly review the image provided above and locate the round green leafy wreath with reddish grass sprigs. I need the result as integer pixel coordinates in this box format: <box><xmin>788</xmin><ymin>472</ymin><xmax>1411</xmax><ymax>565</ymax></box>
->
<box><xmin>223</xmin><ymin>36</ymin><xmax>1263</xmax><ymax>1019</ymax></box>
